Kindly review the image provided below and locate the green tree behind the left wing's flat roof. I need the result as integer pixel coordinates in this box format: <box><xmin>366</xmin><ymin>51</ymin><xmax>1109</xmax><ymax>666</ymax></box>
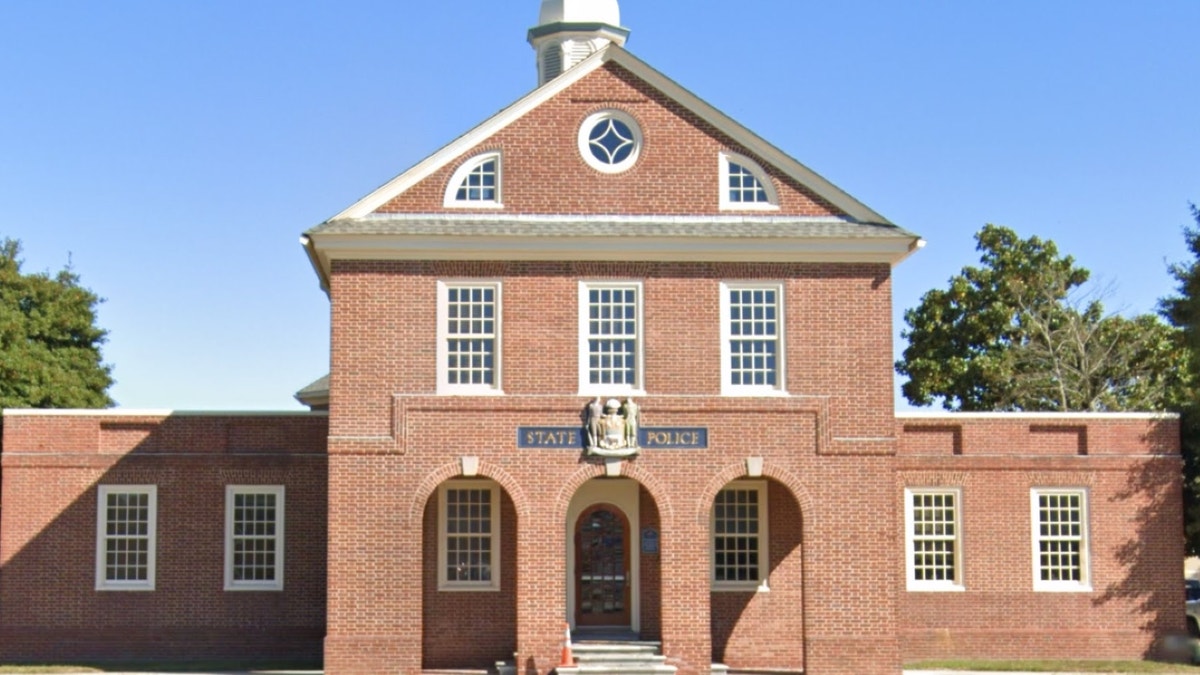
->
<box><xmin>0</xmin><ymin>238</ymin><xmax>113</xmax><ymax>408</ymax></box>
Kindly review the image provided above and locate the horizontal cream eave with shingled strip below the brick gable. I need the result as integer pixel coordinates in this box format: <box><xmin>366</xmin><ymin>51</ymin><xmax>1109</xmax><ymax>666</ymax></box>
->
<box><xmin>301</xmin><ymin>214</ymin><xmax>925</xmax><ymax>291</ymax></box>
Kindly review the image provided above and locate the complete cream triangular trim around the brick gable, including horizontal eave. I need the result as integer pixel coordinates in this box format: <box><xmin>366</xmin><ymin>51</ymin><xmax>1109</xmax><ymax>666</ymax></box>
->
<box><xmin>301</xmin><ymin>44</ymin><xmax>924</xmax><ymax>291</ymax></box>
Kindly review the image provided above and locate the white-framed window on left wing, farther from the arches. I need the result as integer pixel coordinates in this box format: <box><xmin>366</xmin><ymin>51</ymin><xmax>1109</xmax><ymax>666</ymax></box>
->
<box><xmin>96</xmin><ymin>485</ymin><xmax>158</xmax><ymax>591</ymax></box>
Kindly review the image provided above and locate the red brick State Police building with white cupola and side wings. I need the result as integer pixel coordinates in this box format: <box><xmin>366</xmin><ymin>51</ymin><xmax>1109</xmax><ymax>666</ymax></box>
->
<box><xmin>0</xmin><ymin>0</ymin><xmax>1183</xmax><ymax>675</ymax></box>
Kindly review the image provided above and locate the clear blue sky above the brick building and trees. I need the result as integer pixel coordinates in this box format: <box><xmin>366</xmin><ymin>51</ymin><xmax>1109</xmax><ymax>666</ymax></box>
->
<box><xmin>0</xmin><ymin>0</ymin><xmax>1200</xmax><ymax>410</ymax></box>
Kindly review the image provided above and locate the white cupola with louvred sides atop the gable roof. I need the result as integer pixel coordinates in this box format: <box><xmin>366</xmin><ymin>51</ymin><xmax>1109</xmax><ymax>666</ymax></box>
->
<box><xmin>529</xmin><ymin>0</ymin><xmax>629</xmax><ymax>85</ymax></box>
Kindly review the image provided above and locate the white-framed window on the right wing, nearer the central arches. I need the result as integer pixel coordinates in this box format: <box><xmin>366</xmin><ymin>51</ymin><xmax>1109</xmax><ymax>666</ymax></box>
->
<box><xmin>904</xmin><ymin>488</ymin><xmax>964</xmax><ymax>591</ymax></box>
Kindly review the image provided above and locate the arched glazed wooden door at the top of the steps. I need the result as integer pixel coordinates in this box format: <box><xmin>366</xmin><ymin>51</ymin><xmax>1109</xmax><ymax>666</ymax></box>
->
<box><xmin>572</xmin><ymin>503</ymin><xmax>632</xmax><ymax>628</ymax></box>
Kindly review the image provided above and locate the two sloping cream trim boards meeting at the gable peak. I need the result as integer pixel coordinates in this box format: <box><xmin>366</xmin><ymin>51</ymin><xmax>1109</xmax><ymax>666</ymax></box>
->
<box><xmin>330</xmin><ymin>44</ymin><xmax>892</xmax><ymax>225</ymax></box>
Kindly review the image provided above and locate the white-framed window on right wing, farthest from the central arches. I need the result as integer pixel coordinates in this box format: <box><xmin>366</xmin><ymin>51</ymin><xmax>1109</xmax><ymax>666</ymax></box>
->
<box><xmin>1030</xmin><ymin>488</ymin><xmax>1092</xmax><ymax>591</ymax></box>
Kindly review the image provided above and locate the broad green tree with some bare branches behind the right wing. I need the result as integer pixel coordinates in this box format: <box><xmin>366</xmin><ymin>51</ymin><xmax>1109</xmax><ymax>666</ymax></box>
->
<box><xmin>896</xmin><ymin>225</ymin><xmax>1181</xmax><ymax>412</ymax></box>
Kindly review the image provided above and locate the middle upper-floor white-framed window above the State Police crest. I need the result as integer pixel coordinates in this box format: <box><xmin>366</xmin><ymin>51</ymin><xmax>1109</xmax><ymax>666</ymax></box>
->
<box><xmin>580</xmin><ymin>281</ymin><xmax>642</xmax><ymax>395</ymax></box>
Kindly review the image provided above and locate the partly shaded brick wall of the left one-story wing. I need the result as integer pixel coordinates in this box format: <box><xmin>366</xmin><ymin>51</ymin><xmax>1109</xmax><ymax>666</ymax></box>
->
<box><xmin>0</xmin><ymin>414</ymin><xmax>328</xmax><ymax>663</ymax></box>
